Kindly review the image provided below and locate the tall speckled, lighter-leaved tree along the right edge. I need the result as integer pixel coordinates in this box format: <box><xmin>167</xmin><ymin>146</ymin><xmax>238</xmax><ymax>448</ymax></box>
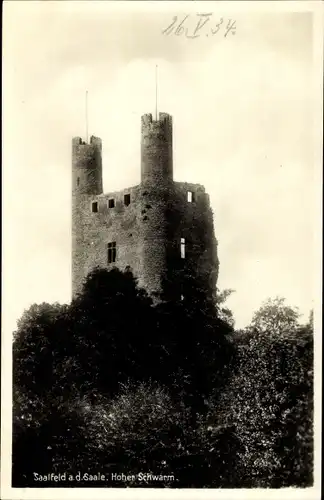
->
<box><xmin>210</xmin><ymin>302</ymin><xmax>313</xmax><ymax>488</ymax></box>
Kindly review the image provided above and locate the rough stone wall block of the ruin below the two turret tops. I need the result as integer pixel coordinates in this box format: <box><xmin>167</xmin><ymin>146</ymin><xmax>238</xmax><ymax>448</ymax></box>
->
<box><xmin>75</xmin><ymin>183</ymin><xmax>218</xmax><ymax>300</ymax></box>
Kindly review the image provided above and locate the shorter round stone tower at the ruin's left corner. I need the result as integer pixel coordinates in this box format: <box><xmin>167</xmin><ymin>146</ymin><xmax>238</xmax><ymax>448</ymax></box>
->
<box><xmin>72</xmin><ymin>136</ymin><xmax>102</xmax><ymax>296</ymax></box>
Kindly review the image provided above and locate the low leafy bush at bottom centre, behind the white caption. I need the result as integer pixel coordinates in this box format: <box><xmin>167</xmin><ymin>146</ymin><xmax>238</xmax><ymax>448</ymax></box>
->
<box><xmin>65</xmin><ymin>381</ymin><xmax>240</xmax><ymax>488</ymax></box>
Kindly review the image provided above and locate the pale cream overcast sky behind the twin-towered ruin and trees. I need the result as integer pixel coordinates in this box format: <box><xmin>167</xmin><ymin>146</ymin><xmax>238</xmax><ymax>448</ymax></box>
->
<box><xmin>3</xmin><ymin>1</ymin><xmax>318</xmax><ymax>336</ymax></box>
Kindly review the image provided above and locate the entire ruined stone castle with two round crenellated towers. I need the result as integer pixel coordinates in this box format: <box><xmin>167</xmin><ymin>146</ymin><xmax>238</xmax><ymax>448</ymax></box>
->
<box><xmin>72</xmin><ymin>113</ymin><xmax>218</xmax><ymax>298</ymax></box>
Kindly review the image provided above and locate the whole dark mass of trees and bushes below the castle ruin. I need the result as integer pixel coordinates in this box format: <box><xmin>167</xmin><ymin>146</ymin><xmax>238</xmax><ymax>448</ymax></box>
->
<box><xmin>12</xmin><ymin>269</ymin><xmax>313</xmax><ymax>488</ymax></box>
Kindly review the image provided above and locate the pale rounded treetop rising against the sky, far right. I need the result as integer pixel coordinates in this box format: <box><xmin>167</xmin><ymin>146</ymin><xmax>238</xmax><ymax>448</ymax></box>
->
<box><xmin>251</xmin><ymin>297</ymin><xmax>300</xmax><ymax>334</ymax></box>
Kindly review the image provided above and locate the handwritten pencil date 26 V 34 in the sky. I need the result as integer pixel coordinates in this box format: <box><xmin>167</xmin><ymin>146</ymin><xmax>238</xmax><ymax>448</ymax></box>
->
<box><xmin>162</xmin><ymin>13</ymin><xmax>236</xmax><ymax>38</ymax></box>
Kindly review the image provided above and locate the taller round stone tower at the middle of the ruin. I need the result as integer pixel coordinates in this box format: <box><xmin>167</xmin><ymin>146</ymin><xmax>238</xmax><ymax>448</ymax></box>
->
<box><xmin>140</xmin><ymin>113</ymin><xmax>173</xmax><ymax>293</ymax></box>
